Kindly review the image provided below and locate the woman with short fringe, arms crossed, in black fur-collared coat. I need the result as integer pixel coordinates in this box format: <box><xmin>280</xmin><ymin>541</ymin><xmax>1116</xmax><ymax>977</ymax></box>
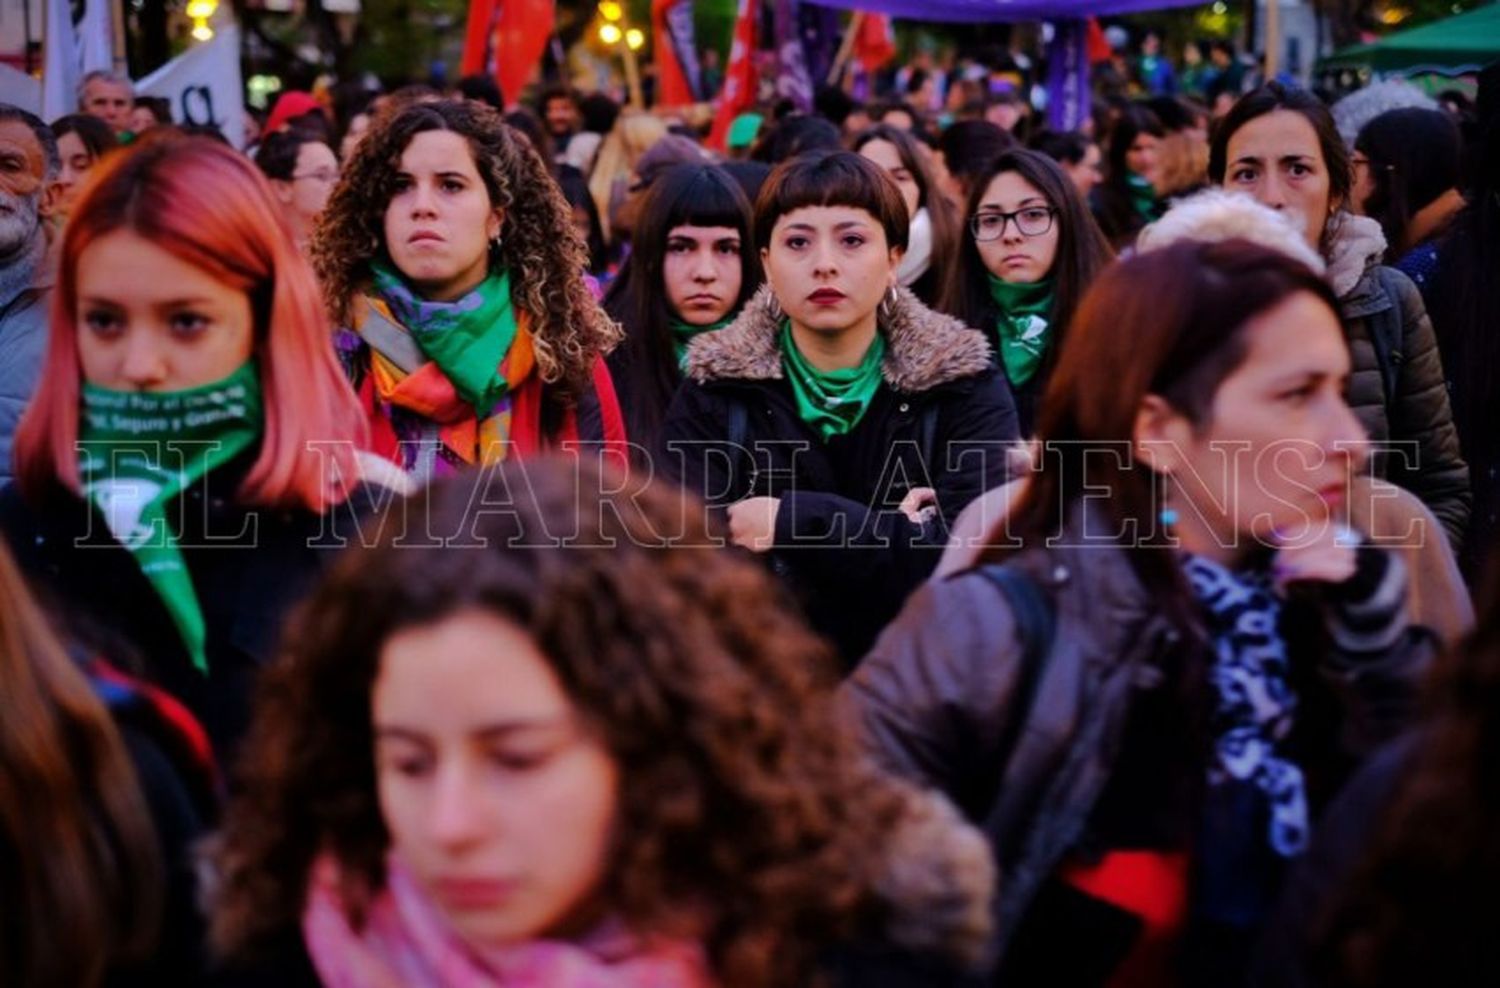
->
<box><xmin>662</xmin><ymin>151</ymin><xmax>1019</xmax><ymax>666</ymax></box>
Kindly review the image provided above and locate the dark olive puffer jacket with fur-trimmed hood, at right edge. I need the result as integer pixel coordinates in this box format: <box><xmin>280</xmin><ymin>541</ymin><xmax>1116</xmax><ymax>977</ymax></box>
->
<box><xmin>1328</xmin><ymin>216</ymin><xmax>1472</xmax><ymax>550</ymax></box>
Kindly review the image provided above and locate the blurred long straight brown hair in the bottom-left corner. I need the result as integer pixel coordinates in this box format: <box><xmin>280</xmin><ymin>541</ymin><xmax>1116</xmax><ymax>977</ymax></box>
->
<box><xmin>0</xmin><ymin>547</ymin><xmax>165</xmax><ymax>988</ymax></box>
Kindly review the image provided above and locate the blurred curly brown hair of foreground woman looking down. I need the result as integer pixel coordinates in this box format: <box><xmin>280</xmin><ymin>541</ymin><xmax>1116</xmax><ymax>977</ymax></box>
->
<box><xmin>213</xmin><ymin>459</ymin><xmax>936</xmax><ymax>988</ymax></box>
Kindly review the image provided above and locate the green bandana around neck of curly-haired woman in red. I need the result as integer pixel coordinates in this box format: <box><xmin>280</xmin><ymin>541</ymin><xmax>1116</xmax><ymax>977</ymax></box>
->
<box><xmin>371</xmin><ymin>261</ymin><xmax>516</xmax><ymax>418</ymax></box>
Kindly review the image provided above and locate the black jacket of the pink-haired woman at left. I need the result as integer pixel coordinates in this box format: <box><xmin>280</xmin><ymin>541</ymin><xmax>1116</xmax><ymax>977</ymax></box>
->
<box><xmin>0</xmin><ymin>448</ymin><xmax>402</xmax><ymax>765</ymax></box>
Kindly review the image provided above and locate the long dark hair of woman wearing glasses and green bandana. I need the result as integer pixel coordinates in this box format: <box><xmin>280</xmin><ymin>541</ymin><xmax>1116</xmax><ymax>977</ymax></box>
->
<box><xmin>939</xmin><ymin>148</ymin><xmax>1115</xmax><ymax>382</ymax></box>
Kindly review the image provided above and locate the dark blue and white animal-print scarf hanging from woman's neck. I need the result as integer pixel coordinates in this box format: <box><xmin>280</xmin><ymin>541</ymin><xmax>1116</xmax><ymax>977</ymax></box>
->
<box><xmin>1182</xmin><ymin>555</ymin><xmax>1310</xmax><ymax>858</ymax></box>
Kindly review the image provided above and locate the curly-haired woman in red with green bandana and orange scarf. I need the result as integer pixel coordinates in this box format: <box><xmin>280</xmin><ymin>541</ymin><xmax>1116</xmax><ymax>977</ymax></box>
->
<box><xmin>312</xmin><ymin>100</ymin><xmax>624</xmax><ymax>483</ymax></box>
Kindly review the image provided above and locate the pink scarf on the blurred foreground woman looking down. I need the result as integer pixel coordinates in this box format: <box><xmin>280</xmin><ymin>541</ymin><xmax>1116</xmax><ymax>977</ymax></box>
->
<box><xmin>302</xmin><ymin>855</ymin><xmax>713</xmax><ymax>988</ymax></box>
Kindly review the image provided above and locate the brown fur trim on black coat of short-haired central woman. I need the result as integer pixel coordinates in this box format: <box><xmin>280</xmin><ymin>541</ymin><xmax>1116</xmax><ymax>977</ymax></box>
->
<box><xmin>687</xmin><ymin>285</ymin><xmax>990</xmax><ymax>394</ymax></box>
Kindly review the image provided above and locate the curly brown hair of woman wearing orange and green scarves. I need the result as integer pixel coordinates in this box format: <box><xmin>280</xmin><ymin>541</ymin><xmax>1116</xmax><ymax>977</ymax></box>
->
<box><xmin>312</xmin><ymin>100</ymin><xmax>620</xmax><ymax>400</ymax></box>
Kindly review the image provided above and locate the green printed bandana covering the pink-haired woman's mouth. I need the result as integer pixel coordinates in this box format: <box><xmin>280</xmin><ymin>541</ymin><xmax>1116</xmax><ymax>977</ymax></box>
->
<box><xmin>78</xmin><ymin>360</ymin><xmax>264</xmax><ymax>673</ymax></box>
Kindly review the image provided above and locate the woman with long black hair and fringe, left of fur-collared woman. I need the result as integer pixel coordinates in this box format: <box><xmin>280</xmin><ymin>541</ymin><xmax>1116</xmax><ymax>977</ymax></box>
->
<box><xmin>605</xmin><ymin>165</ymin><xmax>761</xmax><ymax>454</ymax></box>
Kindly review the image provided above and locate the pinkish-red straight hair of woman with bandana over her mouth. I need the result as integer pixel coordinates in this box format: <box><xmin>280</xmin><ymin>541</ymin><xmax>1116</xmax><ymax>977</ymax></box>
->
<box><xmin>15</xmin><ymin>136</ymin><xmax>368</xmax><ymax>511</ymax></box>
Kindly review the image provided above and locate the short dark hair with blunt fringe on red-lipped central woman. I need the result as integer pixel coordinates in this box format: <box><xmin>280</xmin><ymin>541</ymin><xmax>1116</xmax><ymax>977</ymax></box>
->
<box><xmin>755</xmin><ymin>150</ymin><xmax>911</xmax><ymax>250</ymax></box>
